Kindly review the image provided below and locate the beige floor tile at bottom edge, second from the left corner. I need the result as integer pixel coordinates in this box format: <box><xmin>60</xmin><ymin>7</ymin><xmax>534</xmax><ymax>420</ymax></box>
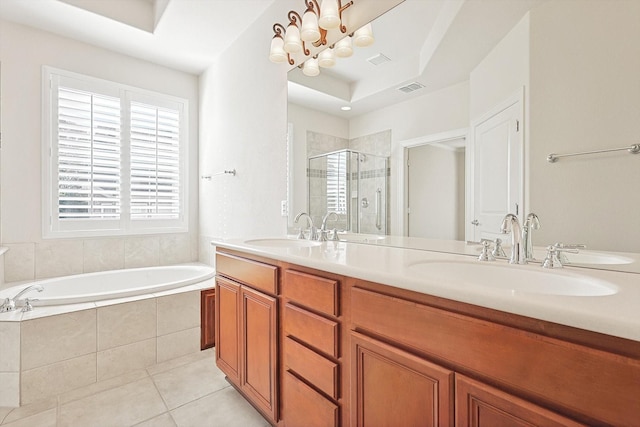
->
<box><xmin>58</xmin><ymin>378</ymin><xmax>167</xmax><ymax>427</ymax></box>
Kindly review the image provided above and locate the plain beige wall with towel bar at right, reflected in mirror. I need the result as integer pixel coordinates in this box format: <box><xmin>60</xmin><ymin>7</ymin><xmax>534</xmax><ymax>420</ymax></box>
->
<box><xmin>530</xmin><ymin>0</ymin><xmax>640</xmax><ymax>252</ymax></box>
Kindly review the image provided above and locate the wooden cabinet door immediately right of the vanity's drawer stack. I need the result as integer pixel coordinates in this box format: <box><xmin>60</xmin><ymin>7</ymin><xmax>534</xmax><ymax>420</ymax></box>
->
<box><xmin>351</xmin><ymin>332</ymin><xmax>453</xmax><ymax>427</ymax></box>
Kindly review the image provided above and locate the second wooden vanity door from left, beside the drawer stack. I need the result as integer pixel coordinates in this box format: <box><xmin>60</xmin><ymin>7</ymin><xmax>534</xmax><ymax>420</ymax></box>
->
<box><xmin>240</xmin><ymin>286</ymin><xmax>278</xmax><ymax>421</ymax></box>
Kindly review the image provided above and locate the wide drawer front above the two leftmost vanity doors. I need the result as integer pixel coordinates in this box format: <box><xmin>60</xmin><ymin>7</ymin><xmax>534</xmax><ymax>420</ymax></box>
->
<box><xmin>216</xmin><ymin>252</ymin><xmax>278</xmax><ymax>294</ymax></box>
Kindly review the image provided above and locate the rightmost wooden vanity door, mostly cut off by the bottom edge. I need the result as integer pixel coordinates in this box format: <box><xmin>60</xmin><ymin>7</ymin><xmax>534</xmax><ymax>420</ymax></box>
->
<box><xmin>456</xmin><ymin>374</ymin><xmax>583</xmax><ymax>427</ymax></box>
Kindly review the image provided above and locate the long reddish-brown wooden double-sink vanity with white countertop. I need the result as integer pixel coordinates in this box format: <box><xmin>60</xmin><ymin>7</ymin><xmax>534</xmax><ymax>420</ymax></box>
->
<box><xmin>213</xmin><ymin>238</ymin><xmax>640</xmax><ymax>426</ymax></box>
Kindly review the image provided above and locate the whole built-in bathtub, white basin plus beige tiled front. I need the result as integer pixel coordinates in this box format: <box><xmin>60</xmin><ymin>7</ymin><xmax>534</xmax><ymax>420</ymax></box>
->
<box><xmin>0</xmin><ymin>264</ymin><xmax>215</xmax><ymax>407</ymax></box>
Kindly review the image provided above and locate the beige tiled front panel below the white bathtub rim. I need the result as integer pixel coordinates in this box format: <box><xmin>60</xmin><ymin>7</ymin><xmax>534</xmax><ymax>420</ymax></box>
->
<box><xmin>0</xmin><ymin>288</ymin><xmax>202</xmax><ymax>406</ymax></box>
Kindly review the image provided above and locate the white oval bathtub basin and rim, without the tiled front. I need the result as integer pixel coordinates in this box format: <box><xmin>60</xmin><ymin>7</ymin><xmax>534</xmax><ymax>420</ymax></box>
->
<box><xmin>0</xmin><ymin>264</ymin><xmax>214</xmax><ymax>306</ymax></box>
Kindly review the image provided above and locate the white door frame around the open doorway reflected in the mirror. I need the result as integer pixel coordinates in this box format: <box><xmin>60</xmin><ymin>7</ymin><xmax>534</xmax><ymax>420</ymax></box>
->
<box><xmin>391</xmin><ymin>128</ymin><xmax>469</xmax><ymax>236</ymax></box>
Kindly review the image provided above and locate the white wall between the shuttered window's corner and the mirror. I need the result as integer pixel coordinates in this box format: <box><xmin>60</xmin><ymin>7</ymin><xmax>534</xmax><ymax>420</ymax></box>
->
<box><xmin>200</xmin><ymin>2</ymin><xmax>293</xmax><ymax>261</ymax></box>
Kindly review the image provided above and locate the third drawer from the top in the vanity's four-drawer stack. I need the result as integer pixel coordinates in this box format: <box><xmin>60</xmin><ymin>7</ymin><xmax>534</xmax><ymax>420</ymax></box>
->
<box><xmin>284</xmin><ymin>337</ymin><xmax>338</xmax><ymax>400</ymax></box>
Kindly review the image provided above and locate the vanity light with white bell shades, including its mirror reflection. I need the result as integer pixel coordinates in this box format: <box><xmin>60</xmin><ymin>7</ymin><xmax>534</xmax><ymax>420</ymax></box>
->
<box><xmin>269</xmin><ymin>0</ymin><xmax>374</xmax><ymax>76</ymax></box>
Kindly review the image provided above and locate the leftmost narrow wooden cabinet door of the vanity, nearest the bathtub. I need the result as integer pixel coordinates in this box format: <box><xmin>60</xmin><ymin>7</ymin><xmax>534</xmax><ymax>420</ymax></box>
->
<box><xmin>215</xmin><ymin>278</ymin><xmax>240</xmax><ymax>385</ymax></box>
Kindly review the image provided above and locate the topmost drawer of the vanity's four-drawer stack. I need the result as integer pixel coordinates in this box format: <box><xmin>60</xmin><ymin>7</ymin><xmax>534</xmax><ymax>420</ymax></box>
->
<box><xmin>282</xmin><ymin>270</ymin><xmax>339</xmax><ymax>317</ymax></box>
